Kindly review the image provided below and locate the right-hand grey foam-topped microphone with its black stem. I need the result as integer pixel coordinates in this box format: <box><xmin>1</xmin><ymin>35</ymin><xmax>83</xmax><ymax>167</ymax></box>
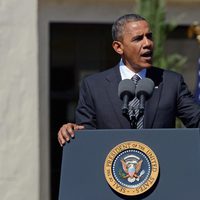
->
<box><xmin>135</xmin><ymin>78</ymin><xmax>155</xmax><ymax>114</ymax></box>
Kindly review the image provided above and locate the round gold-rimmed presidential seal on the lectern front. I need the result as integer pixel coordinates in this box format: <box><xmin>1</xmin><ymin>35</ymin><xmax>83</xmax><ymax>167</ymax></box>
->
<box><xmin>104</xmin><ymin>141</ymin><xmax>159</xmax><ymax>196</ymax></box>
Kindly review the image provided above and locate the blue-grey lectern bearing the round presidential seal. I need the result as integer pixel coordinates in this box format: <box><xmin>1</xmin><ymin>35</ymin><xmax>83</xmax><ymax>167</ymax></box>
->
<box><xmin>59</xmin><ymin>129</ymin><xmax>200</xmax><ymax>200</ymax></box>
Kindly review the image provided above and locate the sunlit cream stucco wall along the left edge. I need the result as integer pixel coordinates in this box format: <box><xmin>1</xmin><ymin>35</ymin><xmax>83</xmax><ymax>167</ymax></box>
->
<box><xmin>0</xmin><ymin>0</ymin><xmax>39</xmax><ymax>200</ymax></box>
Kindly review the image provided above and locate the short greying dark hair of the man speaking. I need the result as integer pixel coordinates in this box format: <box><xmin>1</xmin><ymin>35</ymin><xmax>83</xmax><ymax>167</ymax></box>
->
<box><xmin>112</xmin><ymin>14</ymin><xmax>146</xmax><ymax>41</ymax></box>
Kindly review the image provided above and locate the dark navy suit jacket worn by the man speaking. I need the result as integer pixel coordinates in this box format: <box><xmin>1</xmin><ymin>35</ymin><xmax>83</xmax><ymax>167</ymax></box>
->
<box><xmin>76</xmin><ymin>66</ymin><xmax>200</xmax><ymax>129</ymax></box>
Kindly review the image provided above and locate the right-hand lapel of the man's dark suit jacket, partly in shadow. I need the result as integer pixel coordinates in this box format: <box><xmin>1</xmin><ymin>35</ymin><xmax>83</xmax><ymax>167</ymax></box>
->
<box><xmin>144</xmin><ymin>67</ymin><xmax>163</xmax><ymax>128</ymax></box>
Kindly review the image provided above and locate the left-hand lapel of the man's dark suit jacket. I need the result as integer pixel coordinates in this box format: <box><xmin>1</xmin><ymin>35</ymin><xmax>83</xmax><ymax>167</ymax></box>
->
<box><xmin>106</xmin><ymin>66</ymin><xmax>130</xmax><ymax>128</ymax></box>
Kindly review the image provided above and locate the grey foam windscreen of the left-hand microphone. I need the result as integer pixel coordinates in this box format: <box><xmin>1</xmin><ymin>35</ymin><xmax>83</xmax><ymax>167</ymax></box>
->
<box><xmin>118</xmin><ymin>79</ymin><xmax>135</xmax><ymax>99</ymax></box>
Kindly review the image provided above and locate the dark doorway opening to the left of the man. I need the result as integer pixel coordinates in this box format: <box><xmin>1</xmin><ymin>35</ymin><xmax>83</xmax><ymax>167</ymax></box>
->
<box><xmin>50</xmin><ymin>23</ymin><xmax>119</xmax><ymax>200</ymax></box>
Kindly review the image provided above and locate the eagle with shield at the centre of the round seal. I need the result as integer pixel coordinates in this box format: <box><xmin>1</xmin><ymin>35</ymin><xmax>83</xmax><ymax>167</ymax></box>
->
<box><xmin>119</xmin><ymin>155</ymin><xmax>145</xmax><ymax>183</ymax></box>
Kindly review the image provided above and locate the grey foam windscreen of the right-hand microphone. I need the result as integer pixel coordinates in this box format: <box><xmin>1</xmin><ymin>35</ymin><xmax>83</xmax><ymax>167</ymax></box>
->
<box><xmin>135</xmin><ymin>78</ymin><xmax>155</xmax><ymax>97</ymax></box>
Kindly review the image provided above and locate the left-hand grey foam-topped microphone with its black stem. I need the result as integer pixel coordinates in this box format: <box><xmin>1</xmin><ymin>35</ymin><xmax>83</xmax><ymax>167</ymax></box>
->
<box><xmin>118</xmin><ymin>79</ymin><xmax>135</xmax><ymax>114</ymax></box>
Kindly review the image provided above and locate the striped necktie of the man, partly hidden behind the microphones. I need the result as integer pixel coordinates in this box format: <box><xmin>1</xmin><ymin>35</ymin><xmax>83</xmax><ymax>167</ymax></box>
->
<box><xmin>129</xmin><ymin>74</ymin><xmax>144</xmax><ymax>129</ymax></box>
